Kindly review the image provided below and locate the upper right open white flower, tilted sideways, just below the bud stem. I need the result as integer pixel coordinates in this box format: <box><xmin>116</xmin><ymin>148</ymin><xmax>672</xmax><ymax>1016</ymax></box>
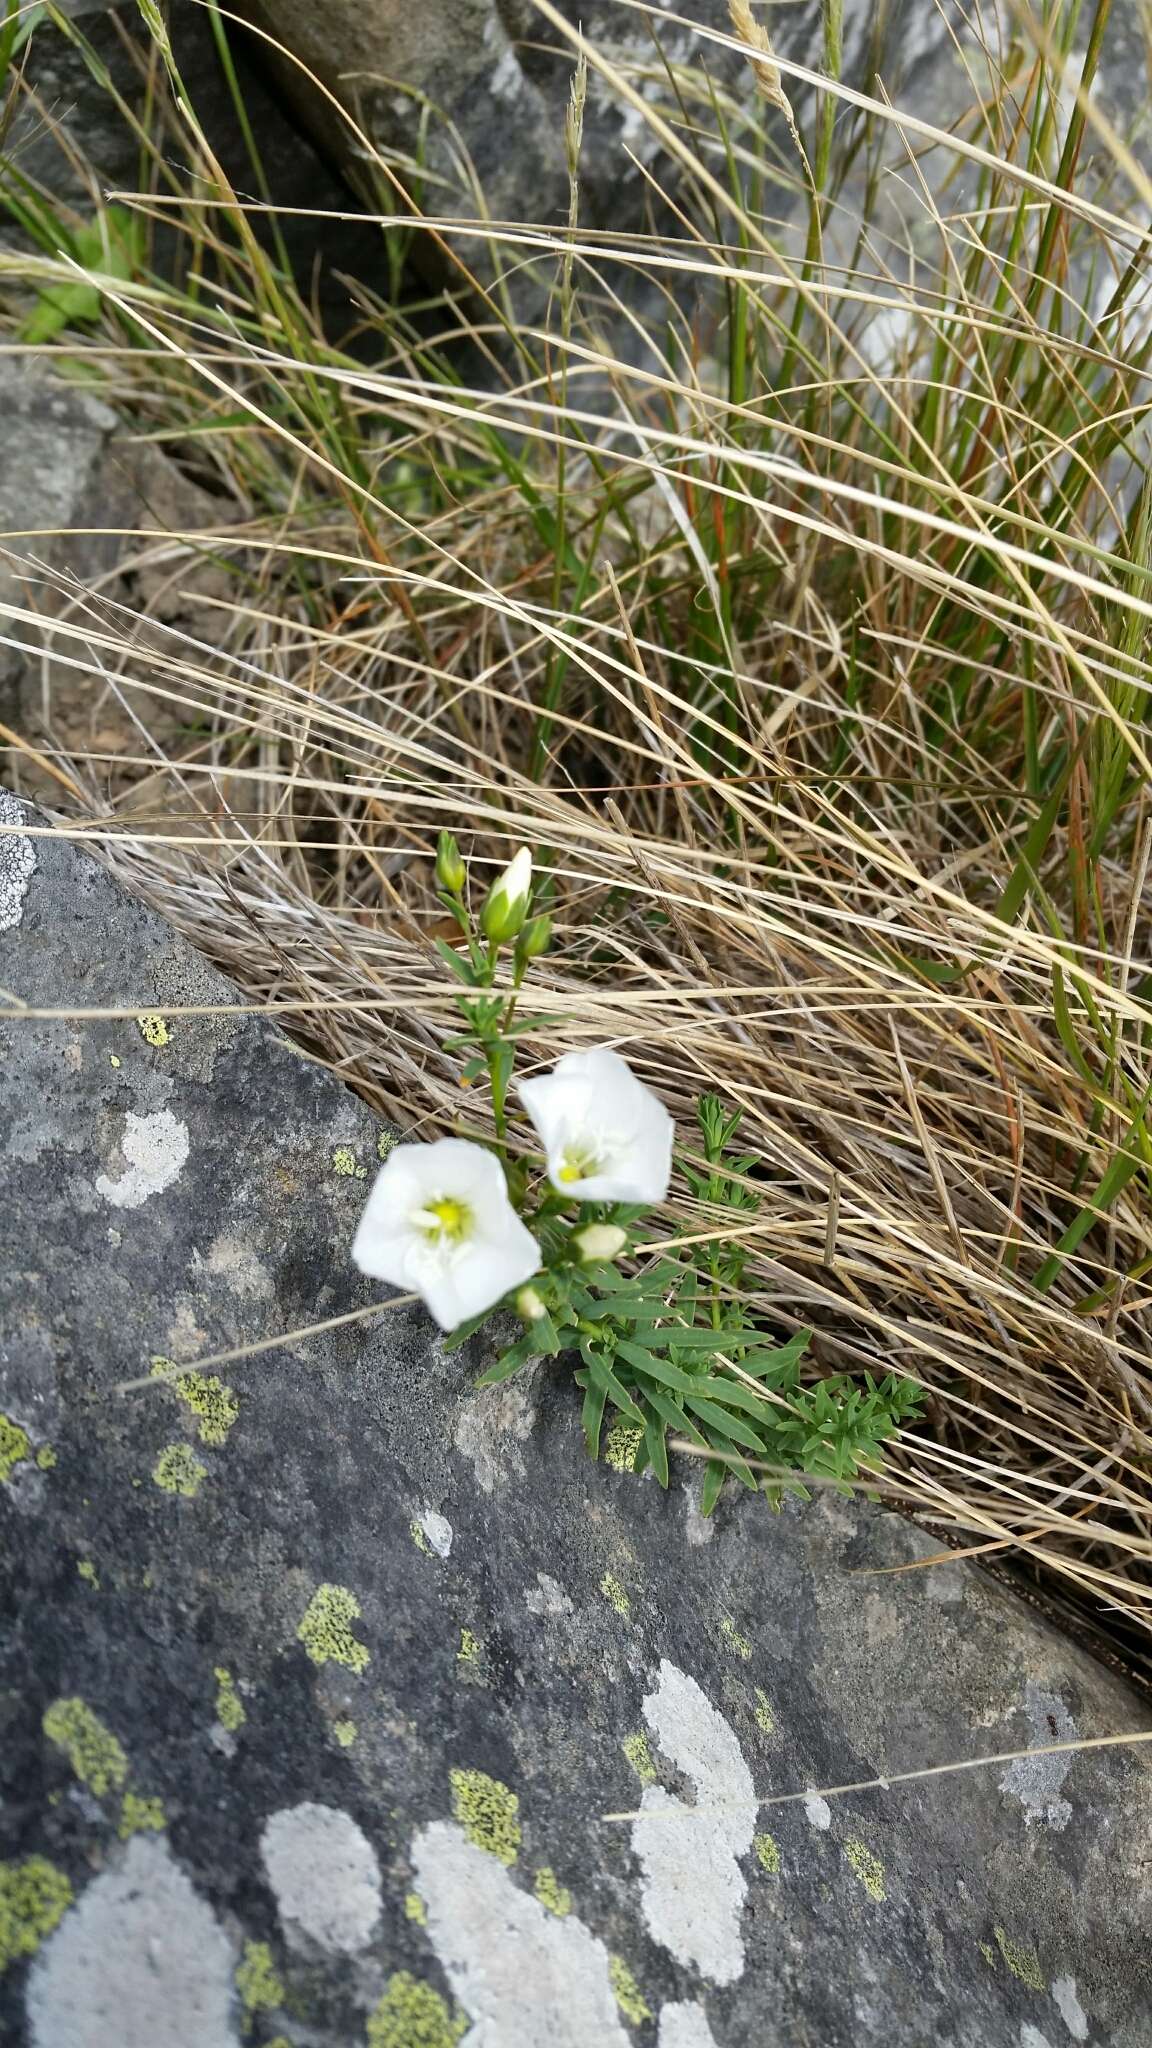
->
<box><xmin>521</xmin><ymin>1047</ymin><xmax>674</xmax><ymax>1202</ymax></box>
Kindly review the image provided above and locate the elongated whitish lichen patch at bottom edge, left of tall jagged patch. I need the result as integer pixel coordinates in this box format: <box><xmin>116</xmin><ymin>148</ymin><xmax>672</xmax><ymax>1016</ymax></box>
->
<box><xmin>412</xmin><ymin>1821</ymin><xmax>629</xmax><ymax>2048</ymax></box>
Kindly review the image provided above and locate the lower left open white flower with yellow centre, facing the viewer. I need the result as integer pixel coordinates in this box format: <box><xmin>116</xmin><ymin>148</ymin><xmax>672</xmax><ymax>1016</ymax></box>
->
<box><xmin>353</xmin><ymin>1139</ymin><xmax>539</xmax><ymax>1329</ymax></box>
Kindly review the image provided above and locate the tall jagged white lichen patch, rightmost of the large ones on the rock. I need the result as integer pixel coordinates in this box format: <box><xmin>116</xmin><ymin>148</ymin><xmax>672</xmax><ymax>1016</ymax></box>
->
<box><xmin>631</xmin><ymin>1659</ymin><xmax>756</xmax><ymax>1985</ymax></box>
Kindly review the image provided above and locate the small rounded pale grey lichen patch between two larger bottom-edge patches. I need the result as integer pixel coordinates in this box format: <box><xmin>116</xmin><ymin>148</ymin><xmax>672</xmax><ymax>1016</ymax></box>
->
<box><xmin>260</xmin><ymin>1800</ymin><xmax>379</xmax><ymax>1956</ymax></box>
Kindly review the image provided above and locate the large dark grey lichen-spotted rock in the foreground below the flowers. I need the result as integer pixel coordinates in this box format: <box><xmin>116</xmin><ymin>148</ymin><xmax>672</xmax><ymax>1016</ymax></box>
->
<box><xmin>0</xmin><ymin>807</ymin><xmax>1152</xmax><ymax>2048</ymax></box>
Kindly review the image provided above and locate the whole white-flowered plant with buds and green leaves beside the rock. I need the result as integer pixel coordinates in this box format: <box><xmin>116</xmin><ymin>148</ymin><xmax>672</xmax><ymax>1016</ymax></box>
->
<box><xmin>353</xmin><ymin>834</ymin><xmax>920</xmax><ymax>1513</ymax></box>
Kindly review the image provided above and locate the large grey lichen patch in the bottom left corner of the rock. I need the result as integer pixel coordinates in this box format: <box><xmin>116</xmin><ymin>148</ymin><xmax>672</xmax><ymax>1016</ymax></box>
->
<box><xmin>27</xmin><ymin>1835</ymin><xmax>238</xmax><ymax>2048</ymax></box>
